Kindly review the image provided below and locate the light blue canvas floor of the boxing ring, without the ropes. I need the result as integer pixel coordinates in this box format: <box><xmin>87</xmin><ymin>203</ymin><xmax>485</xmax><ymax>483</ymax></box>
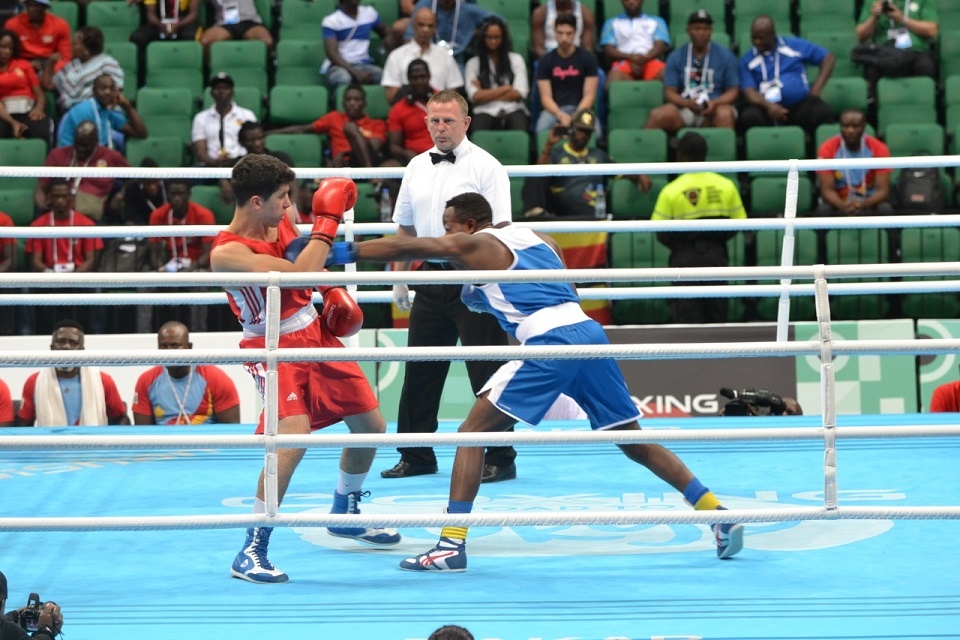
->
<box><xmin>0</xmin><ymin>414</ymin><xmax>960</xmax><ymax>640</ymax></box>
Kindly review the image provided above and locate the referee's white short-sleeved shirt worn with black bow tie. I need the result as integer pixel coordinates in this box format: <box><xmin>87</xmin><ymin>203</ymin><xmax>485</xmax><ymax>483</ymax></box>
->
<box><xmin>393</xmin><ymin>137</ymin><xmax>512</xmax><ymax>238</ymax></box>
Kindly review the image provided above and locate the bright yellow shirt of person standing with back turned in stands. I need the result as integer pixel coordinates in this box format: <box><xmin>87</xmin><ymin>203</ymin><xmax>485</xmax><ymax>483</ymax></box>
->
<box><xmin>650</xmin><ymin>172</ymin><xmax>747</xmax><ymax>220</ymax></box>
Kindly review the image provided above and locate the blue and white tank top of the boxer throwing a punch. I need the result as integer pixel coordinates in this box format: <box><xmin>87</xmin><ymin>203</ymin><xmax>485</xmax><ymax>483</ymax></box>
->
<box><xmin>460</xmin><ymin>226</ymin><xmax>588</xmax><ymax>342</ymax></box>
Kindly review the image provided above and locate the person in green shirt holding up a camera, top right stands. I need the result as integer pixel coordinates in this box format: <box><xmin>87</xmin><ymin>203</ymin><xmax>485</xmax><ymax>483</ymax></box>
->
<box><xmin>854</xmin><ymin>0</ymin><xmax>940</xmax><ymax>88</ymax></box>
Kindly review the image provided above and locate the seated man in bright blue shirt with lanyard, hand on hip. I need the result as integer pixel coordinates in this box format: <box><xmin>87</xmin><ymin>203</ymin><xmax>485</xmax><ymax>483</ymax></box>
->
<box><xmin>738</xmin><ymin>16</ymin><xmax>836</xmax><ymax>136</ymax></box>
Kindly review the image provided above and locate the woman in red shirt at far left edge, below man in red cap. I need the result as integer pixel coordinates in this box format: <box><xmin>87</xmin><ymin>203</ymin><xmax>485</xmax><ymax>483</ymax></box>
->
<box><xmin>0</xmin><ymin>29</ymin><xmax>53</xmax><ymax>149</ymax></box>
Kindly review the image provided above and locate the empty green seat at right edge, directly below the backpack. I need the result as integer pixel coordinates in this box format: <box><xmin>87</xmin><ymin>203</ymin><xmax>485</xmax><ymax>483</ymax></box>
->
<box><xmin>900</xmin><ymin>227</ymin><xmax>960</xmax><ymax>319</ymax></box>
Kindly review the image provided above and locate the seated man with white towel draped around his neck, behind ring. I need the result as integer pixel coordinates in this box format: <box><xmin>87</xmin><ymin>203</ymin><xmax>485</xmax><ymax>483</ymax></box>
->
<box><xmin>17</xmin><ymin>320</ymin><xmax>130</xmax><ymax>427</ymax></box>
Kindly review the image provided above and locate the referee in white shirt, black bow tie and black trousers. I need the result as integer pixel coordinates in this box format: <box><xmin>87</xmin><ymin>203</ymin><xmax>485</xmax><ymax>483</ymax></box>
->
<box><xmin>380</xmin><ymin>90</ymin><xmax>517</xmax><ymax>482</ymax></box>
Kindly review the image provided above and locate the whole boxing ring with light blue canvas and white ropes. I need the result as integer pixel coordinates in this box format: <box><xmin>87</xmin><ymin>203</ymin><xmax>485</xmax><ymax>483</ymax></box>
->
<box><xmin>0</xmin><ymin>159</ymin><xmax>960</xmax><ymax>640</ymax></box>
